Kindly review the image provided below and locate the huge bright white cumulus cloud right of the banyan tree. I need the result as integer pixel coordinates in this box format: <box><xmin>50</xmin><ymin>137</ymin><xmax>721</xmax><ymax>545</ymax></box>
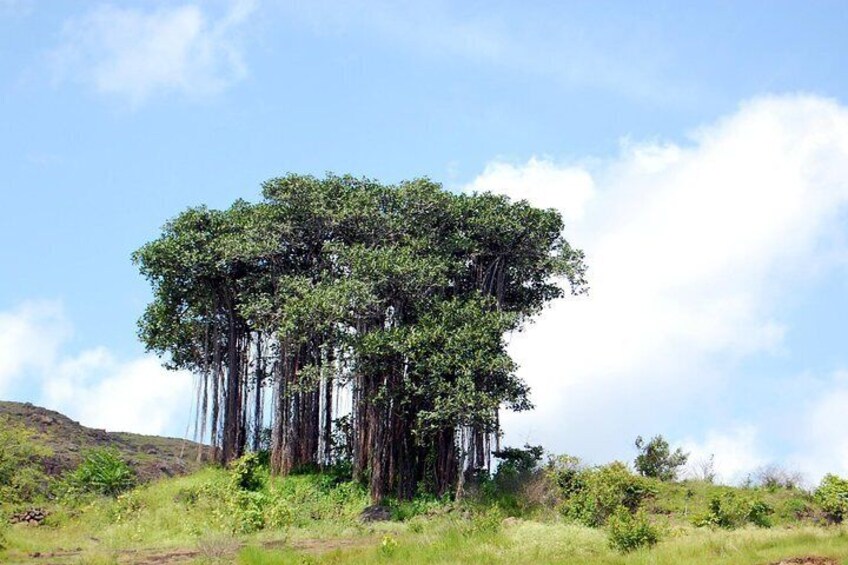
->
<box><xmin>468</xmin><ymin>96</ymin><xmax>848</xmax><ymax>474</ymax></box>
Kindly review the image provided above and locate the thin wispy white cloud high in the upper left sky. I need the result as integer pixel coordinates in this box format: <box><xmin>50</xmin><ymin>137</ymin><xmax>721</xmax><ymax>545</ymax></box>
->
<box><xmin>53</xmin><ymin>0</ymin><xmax>254</xmax><ymax>105</ymax></box>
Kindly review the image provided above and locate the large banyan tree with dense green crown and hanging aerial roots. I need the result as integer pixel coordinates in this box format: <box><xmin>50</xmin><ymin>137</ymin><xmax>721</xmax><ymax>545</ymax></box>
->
<box><xmin>133</xmin><ymin>175</ymin><xmax>585</xmax><ymax>500</ymax></box>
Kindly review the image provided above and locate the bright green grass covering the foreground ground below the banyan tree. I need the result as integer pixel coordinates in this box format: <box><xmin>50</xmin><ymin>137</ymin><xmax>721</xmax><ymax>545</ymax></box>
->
<box><xmin>0</xmin><ymin>462</ymin><xmax>848</xmax><ymax>565</ymax></box>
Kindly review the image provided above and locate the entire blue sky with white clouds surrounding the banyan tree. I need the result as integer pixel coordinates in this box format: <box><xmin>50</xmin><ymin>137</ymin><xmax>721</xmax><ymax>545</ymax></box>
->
<box><xmin>0</xmin><ymin>0</ymin><xmax>848</xmax><ymax>480</ymax></box>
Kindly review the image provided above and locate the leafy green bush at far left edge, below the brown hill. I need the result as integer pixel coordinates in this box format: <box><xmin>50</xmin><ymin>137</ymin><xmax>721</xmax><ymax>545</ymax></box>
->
<box><xmin>0</xmin><ymin>417</ymin><xmax>50</xmax><ymax>506</ymax></box>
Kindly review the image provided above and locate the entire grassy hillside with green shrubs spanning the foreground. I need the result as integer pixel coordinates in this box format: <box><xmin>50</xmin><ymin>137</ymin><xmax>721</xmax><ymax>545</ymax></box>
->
<box><xmin>0</xmin><ymin>403</ymin><xmax>848</xmax><ymax>565</ymax></box>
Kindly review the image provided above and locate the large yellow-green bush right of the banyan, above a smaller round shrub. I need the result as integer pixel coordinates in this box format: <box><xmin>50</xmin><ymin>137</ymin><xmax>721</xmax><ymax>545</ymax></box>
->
<box><xmin>551</xmin><ymin>460</ymin><xmax>656</xmax><ymax>527</ymax></box>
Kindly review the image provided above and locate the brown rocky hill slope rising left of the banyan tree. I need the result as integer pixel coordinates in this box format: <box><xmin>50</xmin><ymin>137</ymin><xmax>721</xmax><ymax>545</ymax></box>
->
<box><xmin>0</xmin><ymin>401</ymin><xmax>201</xmax><ymax>481</ymax></box>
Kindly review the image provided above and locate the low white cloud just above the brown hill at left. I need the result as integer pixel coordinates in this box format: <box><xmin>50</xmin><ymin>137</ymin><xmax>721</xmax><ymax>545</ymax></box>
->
<box><xmin>0</xmin><ymin>302</ymin><xmax>193</xmax><ymax>434</ymax></box>
